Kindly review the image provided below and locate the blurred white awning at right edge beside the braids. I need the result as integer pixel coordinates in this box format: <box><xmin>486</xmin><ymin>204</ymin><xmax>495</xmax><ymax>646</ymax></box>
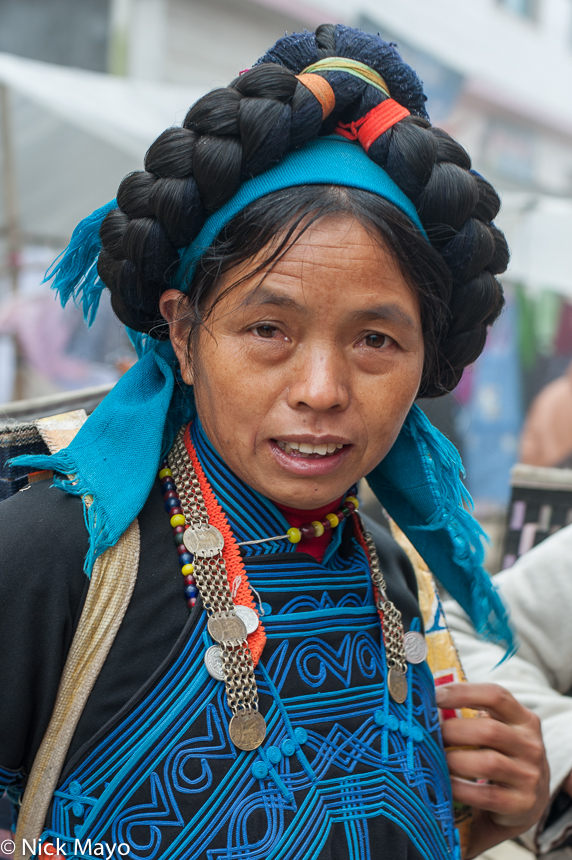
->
<box><xmin>490</xmin><ymin>192</ymin><xmax>572</xmax><ymax>298</ymax></box>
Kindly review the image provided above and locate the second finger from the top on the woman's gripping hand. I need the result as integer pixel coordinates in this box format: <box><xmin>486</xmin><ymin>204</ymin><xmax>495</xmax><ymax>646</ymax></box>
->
<box><xmin>441</xmin><ymin>717</ymin><xmax>544</xmax><ymax>763</ymax></box>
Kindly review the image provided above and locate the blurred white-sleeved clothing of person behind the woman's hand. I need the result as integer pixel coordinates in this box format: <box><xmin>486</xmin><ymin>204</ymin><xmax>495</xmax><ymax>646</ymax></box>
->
<box><xmin>444</xmin><ymin>526</ymin><xmax>572</xmax><ymax>860</ymax></box>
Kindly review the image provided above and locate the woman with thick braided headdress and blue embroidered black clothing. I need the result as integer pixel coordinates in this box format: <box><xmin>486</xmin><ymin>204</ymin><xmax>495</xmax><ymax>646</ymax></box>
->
<box><xmin>0</xmin><ymin>25</ymin><xmax>547</xmax><ymax>860</ymax></box>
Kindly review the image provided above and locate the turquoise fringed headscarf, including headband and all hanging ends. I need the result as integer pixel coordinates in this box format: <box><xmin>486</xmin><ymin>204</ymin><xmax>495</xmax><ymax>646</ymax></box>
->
<box><xmin>13</xmin><ymin>137</ymin><xmax>514</xmax><ymax>652</ymax></box>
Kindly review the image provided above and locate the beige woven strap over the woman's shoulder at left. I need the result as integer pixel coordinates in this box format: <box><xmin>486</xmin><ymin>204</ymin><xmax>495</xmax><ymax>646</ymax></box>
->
<box><xmin>15</xmin><ymin>413</ymin><xmax>140</xmax><ymax>860</ymax></box>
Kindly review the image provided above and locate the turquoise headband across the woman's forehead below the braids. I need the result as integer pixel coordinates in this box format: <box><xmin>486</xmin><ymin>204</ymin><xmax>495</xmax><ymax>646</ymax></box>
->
<box><xmin>174</xmin><ymin>135</ymin><xmax>427</xmax><ymax>292</ymax></box>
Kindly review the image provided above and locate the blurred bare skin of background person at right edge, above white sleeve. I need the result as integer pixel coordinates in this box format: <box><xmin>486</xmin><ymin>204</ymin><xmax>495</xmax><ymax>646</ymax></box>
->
<box><xmin>519</xmin><ymin>364</ymin><xmax>572</xmax><ymax>468</ymax></box>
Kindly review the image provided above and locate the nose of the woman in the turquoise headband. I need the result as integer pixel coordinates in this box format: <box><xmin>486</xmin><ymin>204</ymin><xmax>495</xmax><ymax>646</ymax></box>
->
<box><xmin>288</xmin><ymin>349</ymin><xmax>350</xmax><ymax>412</ymax></box>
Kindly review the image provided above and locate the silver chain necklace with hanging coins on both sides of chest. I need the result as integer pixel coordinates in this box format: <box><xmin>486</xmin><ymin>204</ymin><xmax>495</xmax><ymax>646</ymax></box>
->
<box><xmin>159</xmin><ymin>428</ymin><xmax>427</xmax><ymax>750</ymax></box>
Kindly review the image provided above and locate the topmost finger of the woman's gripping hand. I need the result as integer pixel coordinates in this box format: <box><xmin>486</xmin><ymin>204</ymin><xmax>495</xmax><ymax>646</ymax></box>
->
<box><xmin>435</xmin><ymin>683</ymin><xmax>531</xmax><ymax>725</ymax></box>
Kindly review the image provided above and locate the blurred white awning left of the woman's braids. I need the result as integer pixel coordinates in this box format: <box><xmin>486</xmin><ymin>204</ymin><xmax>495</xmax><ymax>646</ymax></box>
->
<box><xmin>0</xmin><ymin>53</ymin><xmax>202</xmax><ymax>244</ymax></box>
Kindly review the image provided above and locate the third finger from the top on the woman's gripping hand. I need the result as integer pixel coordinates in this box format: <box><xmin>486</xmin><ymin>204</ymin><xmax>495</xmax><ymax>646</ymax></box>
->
<box><xmin>446</xmin><ymin>749</ymin><xmax>538</xmax><ymax>789</ymax></box>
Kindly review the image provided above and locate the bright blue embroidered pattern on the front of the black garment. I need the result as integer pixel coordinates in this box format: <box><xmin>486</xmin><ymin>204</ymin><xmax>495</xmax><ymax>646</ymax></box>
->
<box><xmin>44</xmin><ymin>424</ymin><xmax>455</xmax><ymax>860</ymax></box>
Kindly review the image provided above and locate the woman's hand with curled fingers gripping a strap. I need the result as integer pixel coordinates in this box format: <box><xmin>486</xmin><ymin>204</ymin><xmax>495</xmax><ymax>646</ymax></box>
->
<box><xmin>436</xmin><ymin>684</ymin><xmax>550</xmax><ymax>858</ymax></box>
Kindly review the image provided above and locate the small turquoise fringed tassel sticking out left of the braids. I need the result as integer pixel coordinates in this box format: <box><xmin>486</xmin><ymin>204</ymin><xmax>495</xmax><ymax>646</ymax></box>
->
<box><xmin>43</xmin><ymin>200</ymin><xmax>117</xmax><ymax>326</ymax></box>
